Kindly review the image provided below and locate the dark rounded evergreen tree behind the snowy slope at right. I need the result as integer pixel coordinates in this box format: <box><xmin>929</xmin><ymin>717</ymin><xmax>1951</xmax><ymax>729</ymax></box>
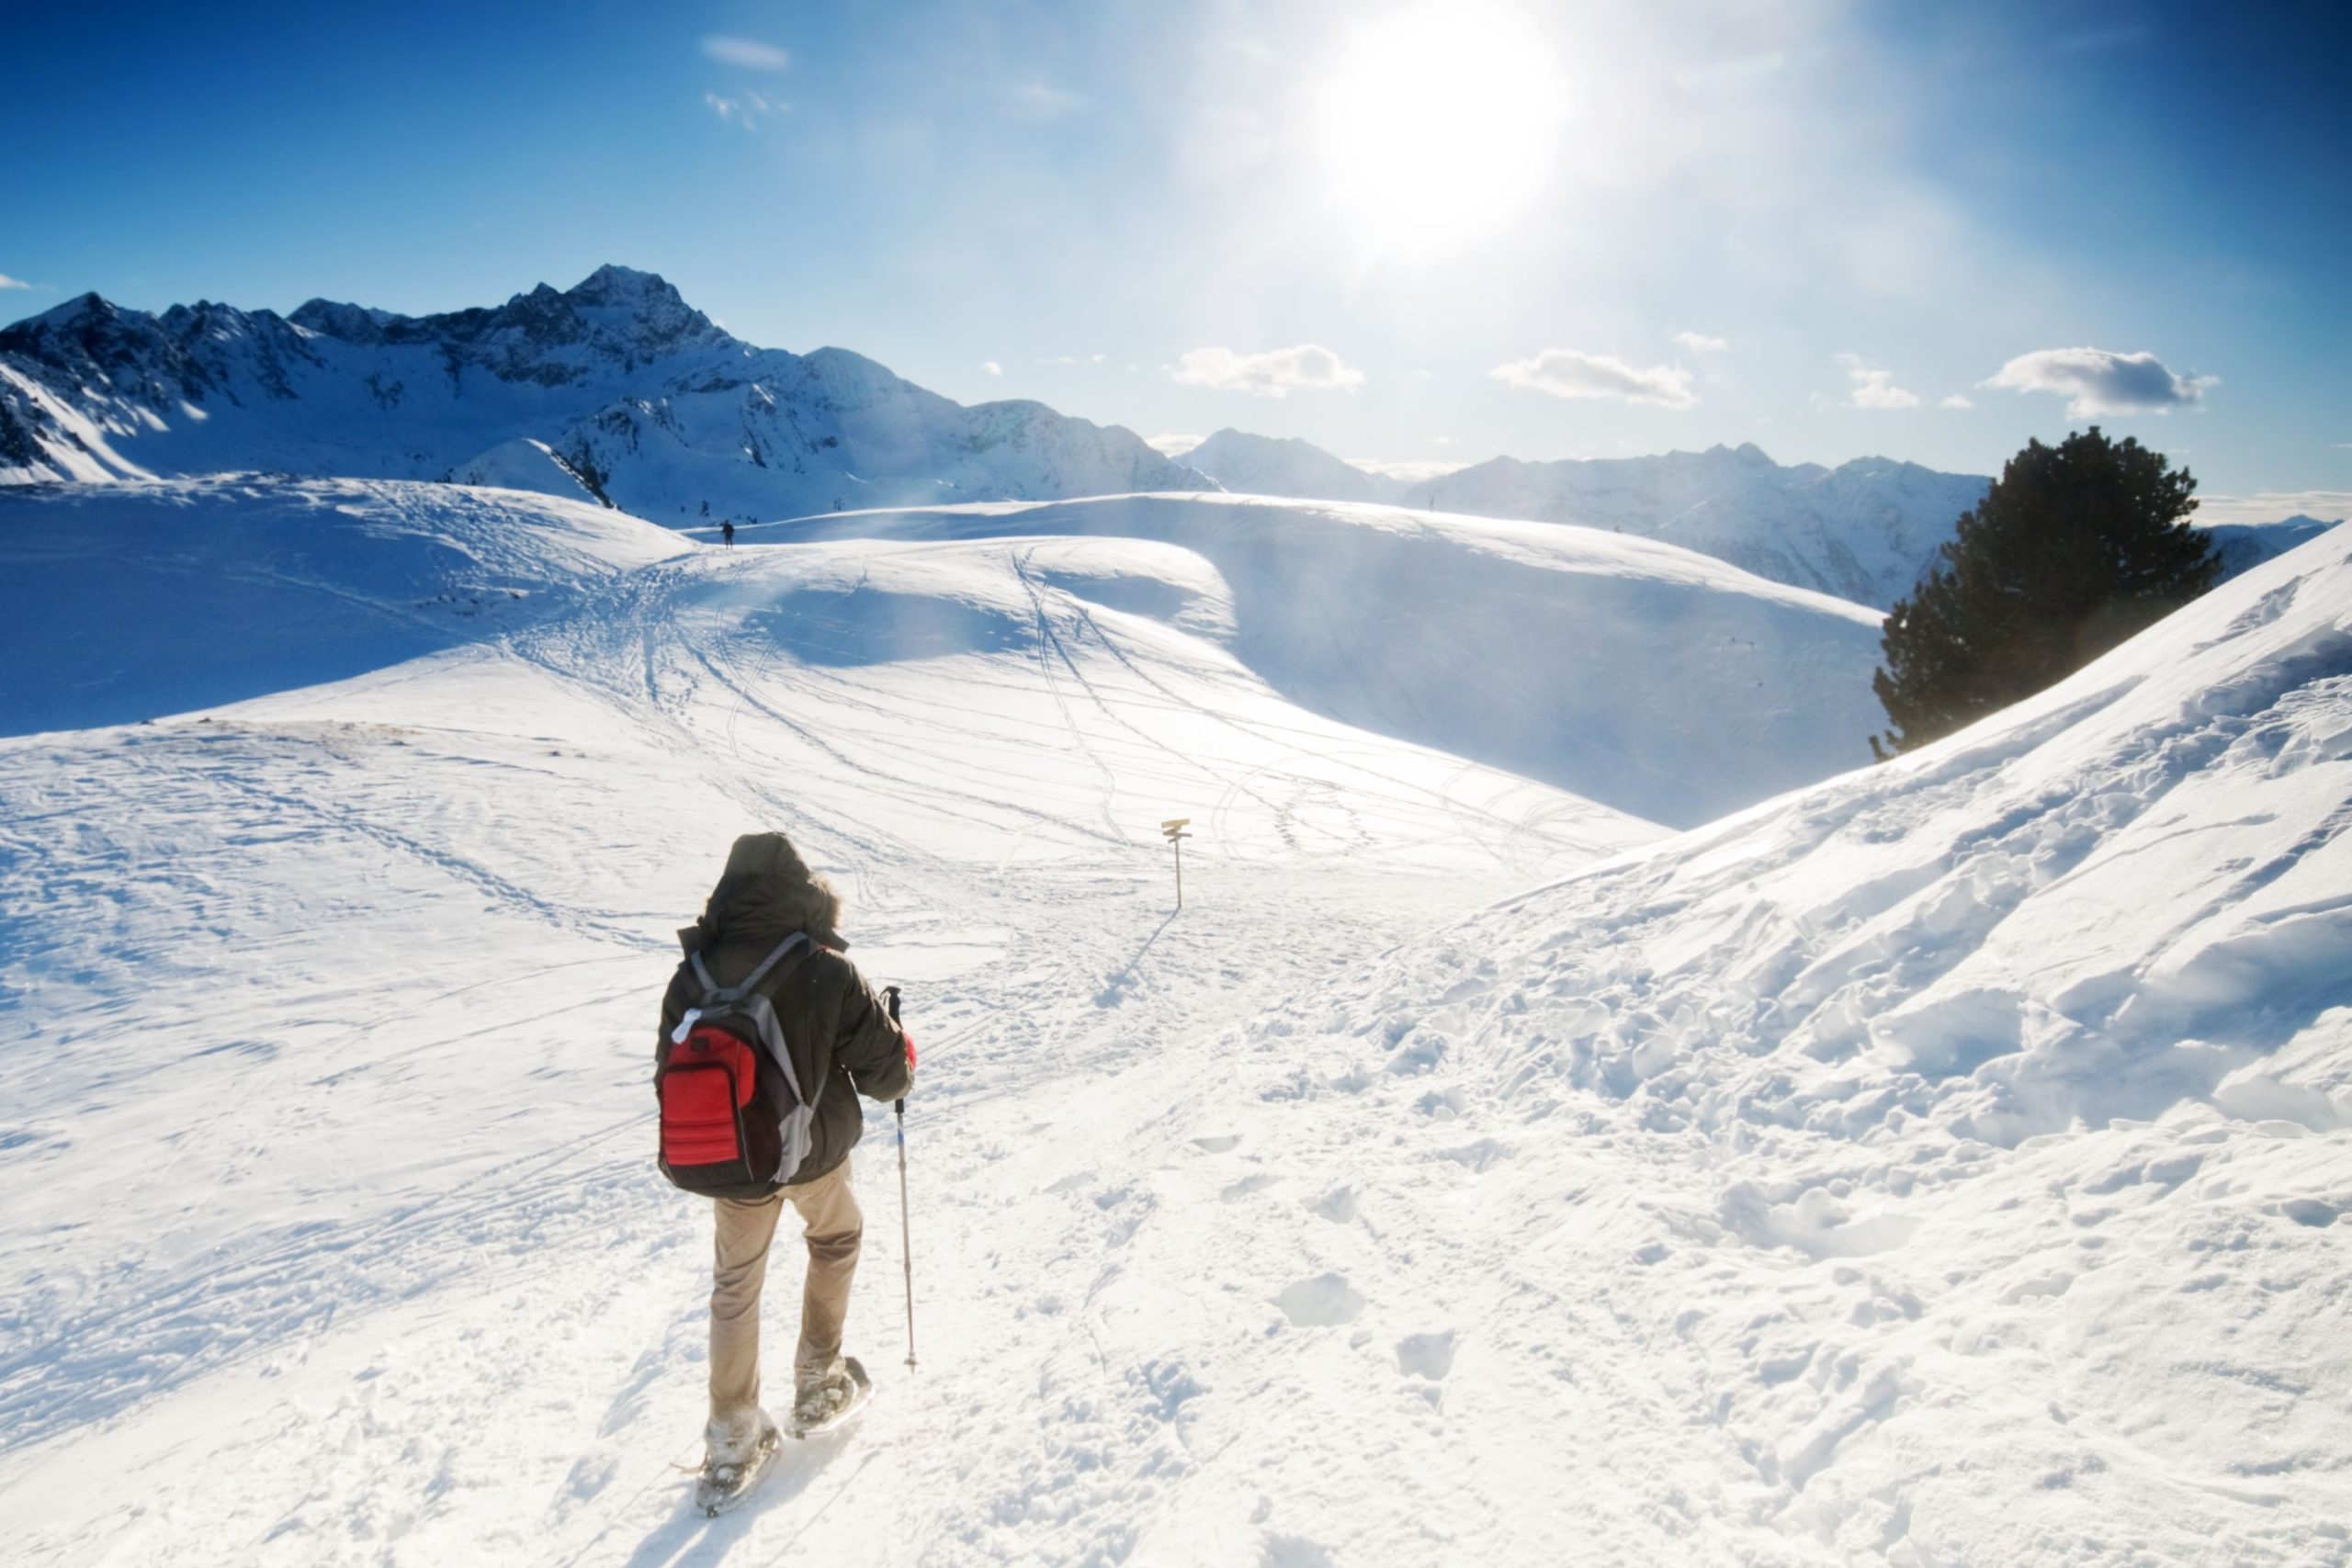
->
<box><xmin>1870</xmin><ymin>425</ymin><xmax>2222</xmax><ymax>761</ymax></box>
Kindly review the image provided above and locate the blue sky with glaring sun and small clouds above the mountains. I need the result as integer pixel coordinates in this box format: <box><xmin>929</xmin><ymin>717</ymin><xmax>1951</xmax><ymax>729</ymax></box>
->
<box><xmin>0</xmin><ymin>0</ymin><xmax>2352</xmax><ymax>514</ymax></box>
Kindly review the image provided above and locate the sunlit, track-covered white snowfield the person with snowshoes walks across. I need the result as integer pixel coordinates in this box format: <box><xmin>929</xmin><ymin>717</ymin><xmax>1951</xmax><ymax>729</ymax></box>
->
<box><xmin>0</xmin><ymin>487</ymin><xmax>2352</xmax><ymax>1568</ymax></box>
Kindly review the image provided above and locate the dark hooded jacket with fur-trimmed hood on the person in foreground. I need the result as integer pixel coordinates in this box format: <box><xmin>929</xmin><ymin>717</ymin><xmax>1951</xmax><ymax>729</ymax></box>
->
<box><xmin>661</xmin><ymin>832</ymin><xmax>915</xmax><ymax>1185</ymax></box>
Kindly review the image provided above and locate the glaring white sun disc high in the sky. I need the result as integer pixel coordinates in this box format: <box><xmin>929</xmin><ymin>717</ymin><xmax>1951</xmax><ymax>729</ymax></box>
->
<box><xmin>1315</xmin><ymin>3</ymin><xmax>1564</xmax><ymax>254</ymax></box>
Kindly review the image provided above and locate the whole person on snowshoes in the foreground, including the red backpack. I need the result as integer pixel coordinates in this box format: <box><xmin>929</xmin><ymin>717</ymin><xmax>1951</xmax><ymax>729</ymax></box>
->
<box><xmin>656</xmin><ymin>832</ymin><xmax>915</xmax><ymax>1512</ymax></box>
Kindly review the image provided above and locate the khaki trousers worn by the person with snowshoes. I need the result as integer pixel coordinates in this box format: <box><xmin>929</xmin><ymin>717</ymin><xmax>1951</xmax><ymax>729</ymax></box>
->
<box><xmin>710</xmin><ymin>1159</ymin><xmax>865</xmax><ymax>1427</ymax></box>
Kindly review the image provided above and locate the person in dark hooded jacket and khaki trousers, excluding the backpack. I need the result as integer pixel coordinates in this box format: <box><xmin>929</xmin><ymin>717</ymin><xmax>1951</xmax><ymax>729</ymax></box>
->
<box><xmin>661</xmin><ymin>832</ymin><xmax>915</xmax><ymax>1495</ymax></box>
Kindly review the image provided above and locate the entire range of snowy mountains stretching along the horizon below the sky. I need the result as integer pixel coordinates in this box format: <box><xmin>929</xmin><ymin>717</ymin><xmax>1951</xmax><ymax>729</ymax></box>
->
<box><xmin>0</xmin><ymin>265</ymin><xmax>2324</xmax><ymax>609</ymax></box>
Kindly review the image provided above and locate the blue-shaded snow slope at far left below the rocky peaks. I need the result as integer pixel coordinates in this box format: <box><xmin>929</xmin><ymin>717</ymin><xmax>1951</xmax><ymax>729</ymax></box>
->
<box><xmin>0</xmin><ymin>479</ymin><xmax>689</xmax><ymax>736</ymax></box>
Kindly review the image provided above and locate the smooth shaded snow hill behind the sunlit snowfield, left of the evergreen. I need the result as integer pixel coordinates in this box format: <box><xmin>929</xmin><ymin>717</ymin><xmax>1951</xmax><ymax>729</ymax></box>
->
<box><xmin>743</xmin><ymin>496</ymin><xmax>1879</xmax><ymax>828</ymax></box>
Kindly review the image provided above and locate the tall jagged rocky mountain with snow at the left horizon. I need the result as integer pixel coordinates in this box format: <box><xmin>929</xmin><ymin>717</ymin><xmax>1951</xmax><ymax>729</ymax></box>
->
<box><xmin>0</xmin><ymin>265</ymin><xmax>1204</xmax><ymax>525</ymax></box>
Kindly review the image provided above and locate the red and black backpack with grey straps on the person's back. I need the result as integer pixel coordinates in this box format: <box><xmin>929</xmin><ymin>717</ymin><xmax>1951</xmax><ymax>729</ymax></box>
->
<box><xmin>654</xmin><ymin>931</ymin><xmax>826</xmax><ymax>1199</ymax></box>
